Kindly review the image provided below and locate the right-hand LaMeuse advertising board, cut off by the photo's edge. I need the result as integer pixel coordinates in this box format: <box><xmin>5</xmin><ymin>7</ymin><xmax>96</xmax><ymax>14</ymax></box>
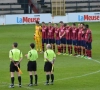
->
<box><xmin>68</xmin><ymin>12</ymin><xmax>100</xmax><ymax>22</ymax></box>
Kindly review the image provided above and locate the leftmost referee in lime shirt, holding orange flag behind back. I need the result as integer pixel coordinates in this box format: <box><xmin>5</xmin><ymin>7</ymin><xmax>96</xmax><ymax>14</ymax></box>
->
<box><xmin>9</xmin><ymin>43</ymin><xmax>23</xmax><ymax>88</ymax></box>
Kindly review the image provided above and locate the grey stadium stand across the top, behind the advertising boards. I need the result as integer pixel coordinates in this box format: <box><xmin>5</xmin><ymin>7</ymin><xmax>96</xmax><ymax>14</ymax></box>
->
<box><xmin>0</xmin><ymin>0</ymin><xmax>100</xmax><ymax>14</ymax></box>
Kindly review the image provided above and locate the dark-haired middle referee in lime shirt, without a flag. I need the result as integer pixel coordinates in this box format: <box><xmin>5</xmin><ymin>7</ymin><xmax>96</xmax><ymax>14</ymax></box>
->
<box><xmin>25</xmin><ymin>43</ymin><xmax>38</xmax><ymax>86</ymax></box>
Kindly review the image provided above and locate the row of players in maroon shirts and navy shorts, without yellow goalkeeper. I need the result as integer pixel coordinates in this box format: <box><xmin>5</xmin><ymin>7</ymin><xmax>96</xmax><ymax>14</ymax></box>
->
<box><xmin>36</xmin><ymin>21</ymin><xmax>92</xmax><ymax>59</ymax></box>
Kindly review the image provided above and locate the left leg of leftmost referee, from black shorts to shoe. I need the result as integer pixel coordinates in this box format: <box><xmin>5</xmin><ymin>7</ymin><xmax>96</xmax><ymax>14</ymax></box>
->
<box><xmin>9</xmin><ymin>62</ymin><xmax>15</xmax><ymax>88</ymax></box>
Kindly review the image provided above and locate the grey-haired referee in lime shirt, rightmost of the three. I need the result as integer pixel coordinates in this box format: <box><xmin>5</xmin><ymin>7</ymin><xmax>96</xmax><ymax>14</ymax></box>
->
<box><xmin>44</xmin><ymin>44</ymin><xmax>56</xmax><ymax>85</ymax></box>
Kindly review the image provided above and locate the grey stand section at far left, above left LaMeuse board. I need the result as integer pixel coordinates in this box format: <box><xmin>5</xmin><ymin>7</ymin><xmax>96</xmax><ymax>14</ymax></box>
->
<box><xmin>0</xmin><ymin>0</ymin><xmax>28</xmax><ymax>15</ymax></box>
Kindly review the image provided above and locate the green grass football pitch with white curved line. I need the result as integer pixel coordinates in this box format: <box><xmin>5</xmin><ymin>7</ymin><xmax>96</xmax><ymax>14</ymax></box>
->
<box><xmin>0</xmin><ymin>22</ymin><xmax>100</xmax><ymax>90</ymax></box>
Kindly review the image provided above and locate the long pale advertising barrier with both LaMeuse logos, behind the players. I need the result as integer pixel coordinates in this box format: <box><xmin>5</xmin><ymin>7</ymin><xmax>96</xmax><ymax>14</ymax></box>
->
<box><xmin>0</xmin><ymin>12</ymin><xmax>100</xmax><ymax>25</ymax></box>
